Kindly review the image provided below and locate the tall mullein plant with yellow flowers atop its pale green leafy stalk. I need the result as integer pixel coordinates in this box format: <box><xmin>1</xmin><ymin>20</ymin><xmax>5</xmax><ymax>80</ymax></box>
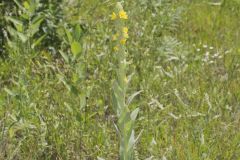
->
<box><xmin>111</xmin><ymin>2</ymin><xmax>139</xmax><ymax>160</ymax></box>
